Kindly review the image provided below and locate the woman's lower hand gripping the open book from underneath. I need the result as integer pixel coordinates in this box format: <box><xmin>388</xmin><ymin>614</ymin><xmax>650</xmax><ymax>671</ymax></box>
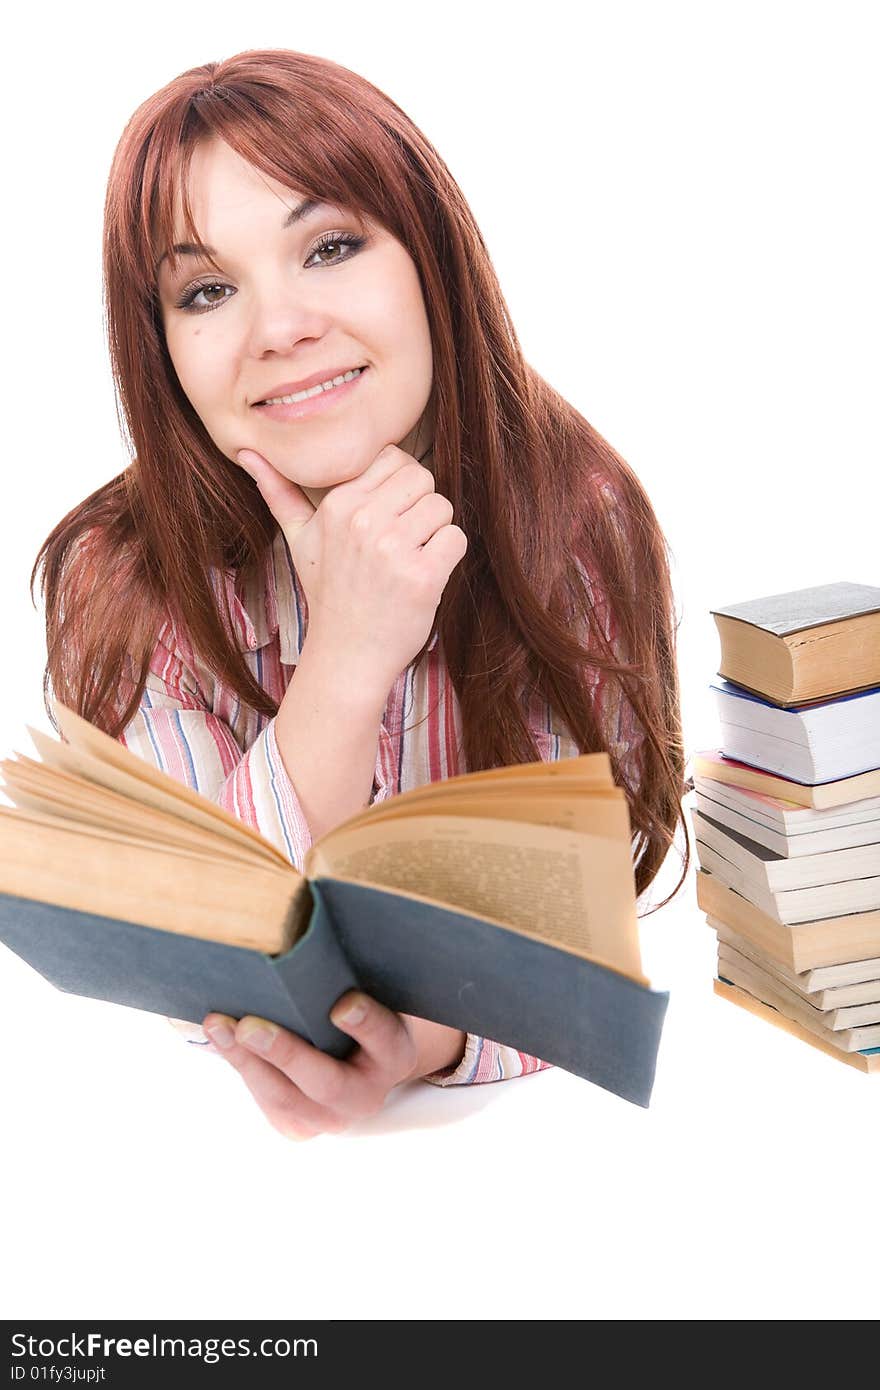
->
<box><xmin>202</xmin><ymin>992</ymin><xmax>433</xmax><ymax>1138</ymax></box>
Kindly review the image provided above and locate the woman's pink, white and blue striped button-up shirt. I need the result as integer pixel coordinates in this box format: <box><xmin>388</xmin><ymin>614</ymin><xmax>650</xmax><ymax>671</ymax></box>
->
<box><xmin>120</xmin><ymin>531</ymin><xmax>639</xmax><ymax>1086</ymax></box>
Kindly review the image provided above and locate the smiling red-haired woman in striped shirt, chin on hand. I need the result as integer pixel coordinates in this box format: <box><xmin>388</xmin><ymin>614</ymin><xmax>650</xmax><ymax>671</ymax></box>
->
<box><xmin>32</xmin><ymin>50</ymin><xmax>688</xmax><ymax>1137</ymax></box>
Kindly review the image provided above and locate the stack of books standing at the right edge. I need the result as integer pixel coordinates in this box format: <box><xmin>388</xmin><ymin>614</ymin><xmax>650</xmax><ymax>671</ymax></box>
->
<box><xmin>691</xmin><ymin>582</ymin><xmax>880</xmax><ymax>1072</ymax></box>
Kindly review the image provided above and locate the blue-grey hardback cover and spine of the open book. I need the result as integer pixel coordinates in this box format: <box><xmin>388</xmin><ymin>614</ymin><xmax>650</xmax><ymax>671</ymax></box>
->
<box><xmin>0</xmin><ymin>878</ymin><xmax>669</xmax><ymax>1106</ymax></box>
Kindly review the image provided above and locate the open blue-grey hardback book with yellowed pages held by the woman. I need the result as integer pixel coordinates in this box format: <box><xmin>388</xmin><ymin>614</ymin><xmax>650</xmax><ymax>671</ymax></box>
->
<box><xmin>0</xmin><ymin>702</ymin><xmax>667</xmax><ymax>1106</ymax></box>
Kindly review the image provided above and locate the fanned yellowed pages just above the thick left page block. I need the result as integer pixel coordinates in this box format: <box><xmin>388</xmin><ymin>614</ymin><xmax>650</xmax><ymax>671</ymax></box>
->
<box><xmin>0</xmin><ymin>753</ymin><xmax>271</xmax><ymax>869</ymax></box>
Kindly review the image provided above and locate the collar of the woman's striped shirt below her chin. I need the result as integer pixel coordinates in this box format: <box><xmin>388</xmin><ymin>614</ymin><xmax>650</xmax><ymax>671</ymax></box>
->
<box><xmin>224</xmin><ymin>530</ymin><xmax>439</xmax><ymax>666</ymax></box>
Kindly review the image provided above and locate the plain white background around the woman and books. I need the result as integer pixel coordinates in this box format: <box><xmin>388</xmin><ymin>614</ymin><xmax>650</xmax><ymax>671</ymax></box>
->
<box><xmin>0</xmin><ymin>0</ymin><xmax>880</xmax><ymax>1319</ymax></box>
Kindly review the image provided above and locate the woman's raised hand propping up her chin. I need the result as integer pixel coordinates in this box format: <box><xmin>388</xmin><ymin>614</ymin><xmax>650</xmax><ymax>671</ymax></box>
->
<box><xmin>238</xmin><ymin>445</ymin><xmax>467</xmax><ymax>694</ymax></box>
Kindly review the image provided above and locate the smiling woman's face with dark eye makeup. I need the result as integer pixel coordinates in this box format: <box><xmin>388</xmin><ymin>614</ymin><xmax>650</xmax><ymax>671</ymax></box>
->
<box><xmin>158</xmin><ymin>139</ymin><xmax>434</xmax><ymax>500</ymax></box>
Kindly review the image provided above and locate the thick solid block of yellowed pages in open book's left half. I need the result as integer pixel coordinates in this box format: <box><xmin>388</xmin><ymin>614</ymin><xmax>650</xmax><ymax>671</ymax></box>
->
<box><xmin>0</xmin><ymin>806</ymin><xmax>301</xmax><ymax>954</ymax></box>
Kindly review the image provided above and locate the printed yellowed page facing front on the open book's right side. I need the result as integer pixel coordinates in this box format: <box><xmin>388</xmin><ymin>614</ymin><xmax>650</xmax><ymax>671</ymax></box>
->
<box><xmin>304</xmin><ymin>802</ymin><xmax>646</xmax><ymax>983</ymax></box>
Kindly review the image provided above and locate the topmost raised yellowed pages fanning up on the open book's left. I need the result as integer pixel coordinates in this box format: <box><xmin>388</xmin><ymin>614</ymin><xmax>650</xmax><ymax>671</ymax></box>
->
<box><xmin>26</xmin><ymin>710</ymin><xmax>289</xmax><ymax>863</ymax></box>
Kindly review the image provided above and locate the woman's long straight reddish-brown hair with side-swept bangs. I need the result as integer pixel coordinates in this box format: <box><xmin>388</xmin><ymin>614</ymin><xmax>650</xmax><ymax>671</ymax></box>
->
<box><xmin>31</xmin><ymin>50</ymin><xmax>690</xmax><ymax>910</ymax></box>
